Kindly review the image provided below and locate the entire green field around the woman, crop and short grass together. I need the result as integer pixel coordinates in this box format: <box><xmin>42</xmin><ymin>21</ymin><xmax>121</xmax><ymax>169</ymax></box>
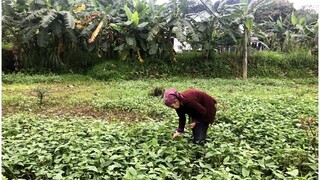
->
<box><xmin>2</xmin><ymin>75</ymin><xmax>318</xmax><ymax>180</ymax></box>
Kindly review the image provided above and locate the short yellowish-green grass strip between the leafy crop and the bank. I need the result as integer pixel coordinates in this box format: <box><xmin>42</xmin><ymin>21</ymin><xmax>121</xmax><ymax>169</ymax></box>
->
<box><xmin>2</xmin><ymin>75</ymin><xmax>317</xmax><ymax>107</ymax></box>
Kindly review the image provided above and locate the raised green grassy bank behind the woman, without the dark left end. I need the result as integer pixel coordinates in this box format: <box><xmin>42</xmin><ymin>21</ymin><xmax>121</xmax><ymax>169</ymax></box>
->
<box><xmin>87</xmin><ymin>52</ymin><xmax>318</xmax><ymax>80</ymax></box>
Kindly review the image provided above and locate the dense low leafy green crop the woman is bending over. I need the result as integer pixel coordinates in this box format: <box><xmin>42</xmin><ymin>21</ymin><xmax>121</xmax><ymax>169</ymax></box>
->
<box><xmin>2</xmin><ymin>95</ymin><xmax>318</xmax><ymax>179</ymax></box>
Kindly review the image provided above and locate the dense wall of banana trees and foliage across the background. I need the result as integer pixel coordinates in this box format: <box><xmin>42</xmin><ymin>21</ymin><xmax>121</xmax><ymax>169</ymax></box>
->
<box><xmin>2</xmin><ymin>0</ymin><xmax>318</xmax><ymax>79</ymax></box>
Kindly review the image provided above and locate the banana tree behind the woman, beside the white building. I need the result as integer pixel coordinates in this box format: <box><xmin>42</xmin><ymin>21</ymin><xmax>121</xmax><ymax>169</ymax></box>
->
<box><xmin>148</xmin><ymin>0</ymin><xmax>199</xmax><ymax>61</ymax></box>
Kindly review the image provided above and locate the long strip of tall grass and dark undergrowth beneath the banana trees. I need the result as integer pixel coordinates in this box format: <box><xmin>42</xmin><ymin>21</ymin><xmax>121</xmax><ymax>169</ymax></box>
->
<box><xmin>3</xmin><ymin>48</ymin><xmax>318</xmax><ymax>80</ymax></box>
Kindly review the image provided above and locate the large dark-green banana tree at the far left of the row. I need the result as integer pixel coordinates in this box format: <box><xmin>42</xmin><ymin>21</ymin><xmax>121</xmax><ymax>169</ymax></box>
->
<box><xmin>3</xmin><ymin>0</ymin><xmax>76</xmax><ymax>69</ymax></box>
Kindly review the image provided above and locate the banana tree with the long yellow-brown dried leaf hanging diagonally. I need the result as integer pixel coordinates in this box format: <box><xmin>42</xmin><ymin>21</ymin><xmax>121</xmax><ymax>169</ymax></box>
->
<box><xmin>75</xmin><ymin>0</ymin><xmax>126</xmax><ymax>58</ymax></box>
